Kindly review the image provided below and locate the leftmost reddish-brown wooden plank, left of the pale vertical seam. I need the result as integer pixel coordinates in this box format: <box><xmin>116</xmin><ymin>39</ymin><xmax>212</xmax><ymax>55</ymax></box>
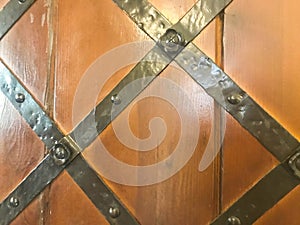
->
<box><xmin>0</xmin><ymin>0</ymin><xmax>48</xmax><ymax>225</ymax></box>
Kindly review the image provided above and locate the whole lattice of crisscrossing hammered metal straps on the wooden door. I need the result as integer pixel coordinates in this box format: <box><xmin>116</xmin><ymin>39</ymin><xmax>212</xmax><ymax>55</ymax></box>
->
<box><xmin>0</xmin><ymin>0</ymin><xmax>299</xmax><ymax>225</ymax></box>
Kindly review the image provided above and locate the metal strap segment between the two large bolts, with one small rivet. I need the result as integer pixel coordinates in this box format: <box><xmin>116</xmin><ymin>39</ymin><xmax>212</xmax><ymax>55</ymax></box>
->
<box><xmin>71</xmin><ymin>46</ymin><xmax>171</xmax><ymax>149</ymax></box>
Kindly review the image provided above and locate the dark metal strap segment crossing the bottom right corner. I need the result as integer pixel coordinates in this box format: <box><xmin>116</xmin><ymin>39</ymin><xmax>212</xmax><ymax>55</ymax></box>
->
<box><xmin>211</xmin><ymin>163</ymin><xmax>299</xmax><ymax>225</ymax></box>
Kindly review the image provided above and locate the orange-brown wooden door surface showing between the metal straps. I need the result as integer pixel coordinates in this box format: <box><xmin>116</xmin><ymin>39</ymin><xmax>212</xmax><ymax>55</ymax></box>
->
<box><xmin>0</xmin><ymin>0</ymin><xmax>300</xmax><ymax>225</ymax></box>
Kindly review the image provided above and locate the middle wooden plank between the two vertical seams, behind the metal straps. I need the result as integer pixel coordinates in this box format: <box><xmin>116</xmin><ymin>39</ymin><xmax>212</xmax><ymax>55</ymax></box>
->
<box><xmin>49</xmin><ymin>0</ymin><xmax>219</xmax><ymax>225</ymax></box>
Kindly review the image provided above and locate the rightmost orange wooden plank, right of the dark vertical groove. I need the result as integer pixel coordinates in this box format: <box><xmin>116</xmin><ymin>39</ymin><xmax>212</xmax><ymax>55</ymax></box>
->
<box><xmin>223</xmin><ymin>1</ymin><xmax>300</xmax><ymax>224</ymax></box>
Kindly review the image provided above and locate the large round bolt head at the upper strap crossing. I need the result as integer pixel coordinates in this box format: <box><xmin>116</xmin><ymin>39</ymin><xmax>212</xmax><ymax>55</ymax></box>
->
<box><xmin>160</xmin><ymin>29</ymin><xmax>184</xmax><ymax>53</ymax></box>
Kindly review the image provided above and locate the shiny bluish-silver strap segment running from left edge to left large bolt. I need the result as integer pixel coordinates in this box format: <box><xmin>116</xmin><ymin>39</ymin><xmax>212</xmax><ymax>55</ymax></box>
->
<box><xmin>0</xmin><ymin>61</ymin><xmax>64</xmax><ymax>149</ymax></box>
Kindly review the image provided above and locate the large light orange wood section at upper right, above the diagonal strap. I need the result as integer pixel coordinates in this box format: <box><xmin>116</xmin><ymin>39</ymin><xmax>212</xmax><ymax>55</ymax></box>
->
<box><xmin>224</xmin><ymin>0</ymin><xmax>300</xmax><ymax>139</ymax></box>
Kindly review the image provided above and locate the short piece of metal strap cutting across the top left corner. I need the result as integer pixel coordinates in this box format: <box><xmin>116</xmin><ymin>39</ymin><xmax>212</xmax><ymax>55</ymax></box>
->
<box><xmin>0</xmin><ymin>0</ymin><xmax>35</xmax><ymax>40</ymax></box>
